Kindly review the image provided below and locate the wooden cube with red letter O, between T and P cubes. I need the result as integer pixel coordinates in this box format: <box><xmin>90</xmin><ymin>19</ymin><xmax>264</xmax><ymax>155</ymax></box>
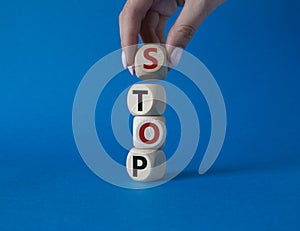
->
<box><xmin>133</xmin><ymin>116</ymin><xmax>167</xmax><ymax>149</ymax></box>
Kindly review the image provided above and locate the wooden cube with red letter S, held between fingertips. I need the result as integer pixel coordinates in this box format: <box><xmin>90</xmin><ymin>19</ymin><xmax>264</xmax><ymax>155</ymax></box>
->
<box><xmin>134</xmin><ymin>44</ymin><xmax>168</xmax><ymax>80</ymax></box>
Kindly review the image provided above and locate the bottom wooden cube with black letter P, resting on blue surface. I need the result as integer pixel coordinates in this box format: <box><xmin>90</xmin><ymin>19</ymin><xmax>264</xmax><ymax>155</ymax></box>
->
<box><xmin>126</xmin><ymin>148</ymin><xmax>166</xmax><ymax>182</ymax></box>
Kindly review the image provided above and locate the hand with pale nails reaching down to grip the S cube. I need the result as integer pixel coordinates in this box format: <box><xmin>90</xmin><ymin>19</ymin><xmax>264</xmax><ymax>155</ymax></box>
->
<box><xmin>119</xmin><ymin>0</ymin><xmax>225</xmax><ymax>75</ymax></box>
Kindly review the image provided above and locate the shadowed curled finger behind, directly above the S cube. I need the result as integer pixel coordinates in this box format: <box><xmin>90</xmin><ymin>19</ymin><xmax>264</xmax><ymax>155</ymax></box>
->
<box><xmin>140</xmin><ymin>10</ymin><xmax>160</xmax><ymax>43</ymax></box>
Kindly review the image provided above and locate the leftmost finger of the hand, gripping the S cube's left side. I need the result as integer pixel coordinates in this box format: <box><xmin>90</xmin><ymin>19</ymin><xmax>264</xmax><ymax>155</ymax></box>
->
<box><xmin>119</xmin><ymin>0</ymin><xmax>153</xmax><ymax>66</ymax></box>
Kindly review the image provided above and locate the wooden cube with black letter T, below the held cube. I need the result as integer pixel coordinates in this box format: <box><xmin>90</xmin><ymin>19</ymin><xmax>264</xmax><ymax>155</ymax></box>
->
<box><xmin>127</xmin><ymin>84</ymin><xmax>166</xmax><ymax>116</ymax></box>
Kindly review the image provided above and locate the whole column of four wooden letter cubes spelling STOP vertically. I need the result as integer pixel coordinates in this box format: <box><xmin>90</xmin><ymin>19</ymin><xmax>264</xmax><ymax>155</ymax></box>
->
<box><xmin>126</xmin><ymin>44</ymin><xmax>168</xmax><ymax>181</ymax></box>
